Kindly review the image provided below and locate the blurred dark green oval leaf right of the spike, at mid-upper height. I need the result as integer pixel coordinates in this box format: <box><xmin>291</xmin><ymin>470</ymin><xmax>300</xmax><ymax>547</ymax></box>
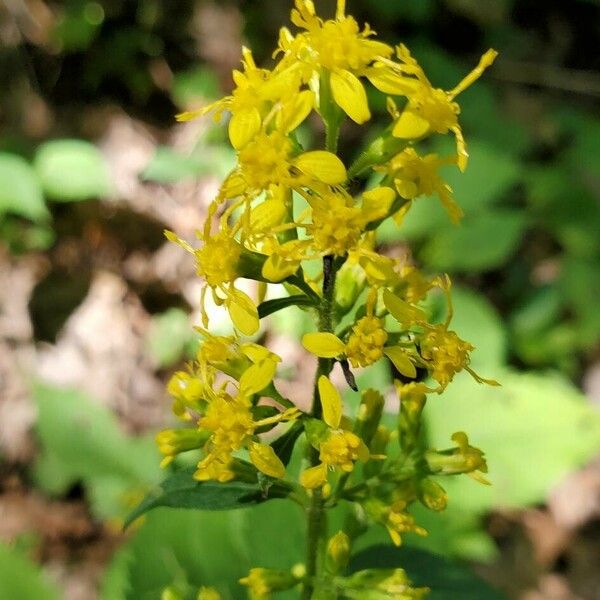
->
<box><xmin>421</xmin><ymin>210</ymin><xmax>527</xmax><ymax>273</ymax></box>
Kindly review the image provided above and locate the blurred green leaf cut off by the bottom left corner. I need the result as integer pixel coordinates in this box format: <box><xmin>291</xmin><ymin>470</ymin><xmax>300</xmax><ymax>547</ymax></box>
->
<box><xmin>0</xmin><ymin>544</ymin><xmax>61</xmax><ymax>600</ymax></box>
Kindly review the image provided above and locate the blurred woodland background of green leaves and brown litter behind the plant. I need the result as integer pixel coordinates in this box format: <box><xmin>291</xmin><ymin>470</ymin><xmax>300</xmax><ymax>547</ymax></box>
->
<box><xmin>0</xmin><ymin>0</ymin><xmax>600</xmax><ymax>600</ymax></box>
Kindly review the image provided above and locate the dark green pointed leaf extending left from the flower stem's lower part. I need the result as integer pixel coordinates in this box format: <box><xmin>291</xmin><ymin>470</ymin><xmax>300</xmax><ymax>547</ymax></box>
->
<box><xmin>125</xmin><ymin>467</ymin><xmax>290</xmax><ymax>527</ymax></box>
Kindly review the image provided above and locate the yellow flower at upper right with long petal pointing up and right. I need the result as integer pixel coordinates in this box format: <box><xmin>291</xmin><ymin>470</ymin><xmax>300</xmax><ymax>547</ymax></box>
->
<box><xmin>371</xmin><ymin>44</ymin><xmax>498</xmax><ymax>171</ymax></box>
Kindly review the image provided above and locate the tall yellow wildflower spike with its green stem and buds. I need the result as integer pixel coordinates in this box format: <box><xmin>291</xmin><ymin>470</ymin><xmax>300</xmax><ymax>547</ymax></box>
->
<box><xmin>136</xmin><ymin>0</ymin><xmax>496</xmax><ymax>600</ymax></box>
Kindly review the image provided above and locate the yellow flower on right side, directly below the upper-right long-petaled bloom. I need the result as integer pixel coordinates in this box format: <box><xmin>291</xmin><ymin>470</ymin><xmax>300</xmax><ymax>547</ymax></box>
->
<box><xmin>379</xmin><ymin>148</ymin><xmax>463</xmax><ymax>223</ymax></box>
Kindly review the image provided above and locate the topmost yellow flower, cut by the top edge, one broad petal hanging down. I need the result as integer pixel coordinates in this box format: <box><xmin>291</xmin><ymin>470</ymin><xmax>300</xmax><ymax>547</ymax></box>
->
<box><xmin>279</xmin><ymin>0</ymin><xmax>393</xmax><ymax>123</ymax></box>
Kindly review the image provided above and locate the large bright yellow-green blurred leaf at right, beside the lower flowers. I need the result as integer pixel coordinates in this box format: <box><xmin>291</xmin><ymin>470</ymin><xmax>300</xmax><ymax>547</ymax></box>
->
<box><xmin>425</xmin><ymin>371</ymin><xmax>600</xmax><ymax>514</ymax></box>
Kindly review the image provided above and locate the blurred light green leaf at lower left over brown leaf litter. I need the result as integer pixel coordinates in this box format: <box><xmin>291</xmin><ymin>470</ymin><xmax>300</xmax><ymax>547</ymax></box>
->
<box><xmin>33</xmin><ymin>384</ymin><xmax>160</xmax><ymax>518</ymax></box>
